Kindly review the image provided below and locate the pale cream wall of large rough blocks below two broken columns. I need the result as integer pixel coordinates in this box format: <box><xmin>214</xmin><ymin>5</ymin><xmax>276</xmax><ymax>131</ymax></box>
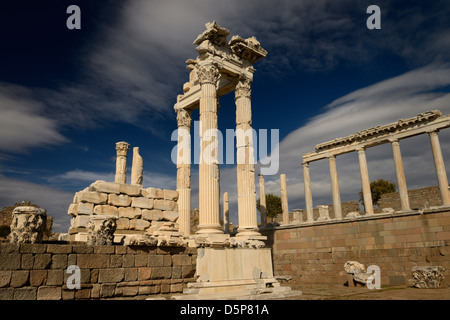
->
<box><xmin>68</xmin><ymin>181</ymin><xmax>178</xmax><ymax>241</ymax></box>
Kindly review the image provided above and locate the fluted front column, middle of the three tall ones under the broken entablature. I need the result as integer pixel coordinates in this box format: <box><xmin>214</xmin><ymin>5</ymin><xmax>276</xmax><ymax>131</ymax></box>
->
<box><xmin>197</xmin><ymin>63</ymin><xmax>223</xmax><ymax>234</ymax></box>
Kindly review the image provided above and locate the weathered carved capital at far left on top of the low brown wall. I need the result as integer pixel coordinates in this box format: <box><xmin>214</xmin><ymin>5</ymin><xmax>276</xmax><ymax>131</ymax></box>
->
<box><xmin>10</xmin><ymin>206</ymin><xmax>47</xmax><ymax>243</ymax></box>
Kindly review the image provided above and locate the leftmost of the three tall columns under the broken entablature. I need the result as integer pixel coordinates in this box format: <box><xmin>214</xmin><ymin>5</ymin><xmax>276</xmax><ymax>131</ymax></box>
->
<box><xmin>176</xmin><ymin>109</ymin><xmax>192</xmax><ymax>236</ymax></box>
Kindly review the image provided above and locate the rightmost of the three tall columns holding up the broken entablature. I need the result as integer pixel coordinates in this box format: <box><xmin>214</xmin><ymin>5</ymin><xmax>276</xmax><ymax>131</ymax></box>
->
<box><xmin>235</xmin><ymin>79</ymin><xmax>261</xmax><ymax>237</ymax></box>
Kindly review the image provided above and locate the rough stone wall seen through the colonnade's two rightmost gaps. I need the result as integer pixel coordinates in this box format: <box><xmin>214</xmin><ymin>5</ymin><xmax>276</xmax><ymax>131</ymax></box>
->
<box><xmin>378</xmin><ymin>186</ymin><xmax>442</xmax><ymax>211</ymax></box>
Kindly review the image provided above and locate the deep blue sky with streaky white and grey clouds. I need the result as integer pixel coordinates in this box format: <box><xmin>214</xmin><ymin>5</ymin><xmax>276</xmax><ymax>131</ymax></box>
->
<box><xmin>0</xmin><ymin>0</ymin><xmax>450</xmax><ymax>232</ymax></box>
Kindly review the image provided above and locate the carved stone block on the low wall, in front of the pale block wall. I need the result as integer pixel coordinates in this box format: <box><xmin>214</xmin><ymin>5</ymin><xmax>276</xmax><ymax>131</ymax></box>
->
<box><xmin>86</xmin><ymin>215</ymin><xmax>117</xmax><ymax>245</ymax></box>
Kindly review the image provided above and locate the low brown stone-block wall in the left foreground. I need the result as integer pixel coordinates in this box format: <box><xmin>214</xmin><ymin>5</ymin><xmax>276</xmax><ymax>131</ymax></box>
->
<box><xmin>0</xmin><ymin>242</ymin><xmax>197</xmax><ymax>300</ymax></box>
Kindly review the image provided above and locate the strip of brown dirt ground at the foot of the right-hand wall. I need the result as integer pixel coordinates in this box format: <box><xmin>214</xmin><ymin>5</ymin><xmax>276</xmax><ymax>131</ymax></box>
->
<box><xmin>288</xmin><ymin>285</ymin><xmax>450</xmax><ymax>300</ymax></box>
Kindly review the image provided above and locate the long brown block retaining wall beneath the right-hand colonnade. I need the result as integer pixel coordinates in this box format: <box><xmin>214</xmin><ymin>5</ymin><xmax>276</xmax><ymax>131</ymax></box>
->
<box><xmin>265</xmin><ymin>209</ymin><xmax>450</xmax><ymax>287</ymax></box>
